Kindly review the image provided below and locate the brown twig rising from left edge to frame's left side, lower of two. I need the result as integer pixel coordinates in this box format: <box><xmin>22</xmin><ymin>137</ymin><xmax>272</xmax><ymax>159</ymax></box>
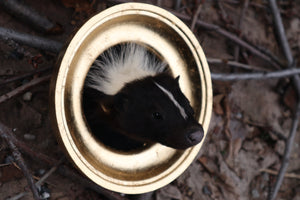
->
<box><xmin>0</xmin><ymin>75</ymin><xmax>51</xmax><ymax>103</ymax></box>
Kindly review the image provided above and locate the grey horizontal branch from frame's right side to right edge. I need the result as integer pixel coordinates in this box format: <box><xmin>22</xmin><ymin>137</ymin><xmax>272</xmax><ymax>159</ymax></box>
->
<box><xmin>211</xmin><ymin>68</ymin><xmax>300</xmax><ymax>81</ymax></box>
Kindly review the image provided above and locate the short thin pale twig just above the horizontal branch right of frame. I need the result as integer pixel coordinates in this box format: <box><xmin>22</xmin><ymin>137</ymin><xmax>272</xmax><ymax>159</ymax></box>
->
<box><xmin>206</xmin><ymin>58</ymin><xmax>270</xmax><ymax>72</ymax></box>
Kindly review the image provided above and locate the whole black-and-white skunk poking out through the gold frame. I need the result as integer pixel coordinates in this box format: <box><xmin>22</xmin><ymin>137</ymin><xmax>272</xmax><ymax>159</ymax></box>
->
<box><xmin>83</xmin><ymin>43</ymin><xmax>203</xmax><ymax>150</ymax></box>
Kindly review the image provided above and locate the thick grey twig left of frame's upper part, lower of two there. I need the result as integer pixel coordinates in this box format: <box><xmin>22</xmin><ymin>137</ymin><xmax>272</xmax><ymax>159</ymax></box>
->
<box><xmin>0</xmin><ymin>27</ymin><xmax>62</xmax><ymax>53</ymax></box>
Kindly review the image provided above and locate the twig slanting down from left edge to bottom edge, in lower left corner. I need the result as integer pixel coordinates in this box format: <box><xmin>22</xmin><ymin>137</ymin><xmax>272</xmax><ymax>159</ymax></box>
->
<box><xmin>0</xmin><ymin>122</ymin><xmax>40</xmax><ymax>200</ymax></box>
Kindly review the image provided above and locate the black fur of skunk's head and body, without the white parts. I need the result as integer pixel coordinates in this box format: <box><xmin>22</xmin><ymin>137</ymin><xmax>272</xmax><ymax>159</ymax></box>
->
<box><xmin>83</xmin><ymin>73</ymin><xmax>203</xmax><ymax>150</ymax></box>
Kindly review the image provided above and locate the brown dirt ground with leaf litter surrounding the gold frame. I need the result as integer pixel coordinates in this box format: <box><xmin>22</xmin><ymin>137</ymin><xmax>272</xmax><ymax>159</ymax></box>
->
<box><xmin>0</xmin><ymin>0</ymin><xmax>300</xmax><ymax>200</ymax></box>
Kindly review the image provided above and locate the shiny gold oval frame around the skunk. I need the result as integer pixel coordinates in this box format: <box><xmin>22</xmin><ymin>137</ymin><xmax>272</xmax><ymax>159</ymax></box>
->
<box><xmin>50</xmin><ymin>3</ymin><xmax>212</xmax><ymax>194</ymax></box>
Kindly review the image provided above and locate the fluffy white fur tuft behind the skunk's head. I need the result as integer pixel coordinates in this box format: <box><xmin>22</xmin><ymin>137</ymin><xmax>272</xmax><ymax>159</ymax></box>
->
<box><xmin>86</xmin><ymin>43</ymin><xmax>167</xmax><ymax>95</ymax></box>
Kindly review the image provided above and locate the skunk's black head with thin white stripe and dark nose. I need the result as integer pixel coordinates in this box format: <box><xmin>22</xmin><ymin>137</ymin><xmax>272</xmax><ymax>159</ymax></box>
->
<box><xmin>113</xmin><ymin>74</ymin><xmax>203</xmax><ymax>149</ymax></box>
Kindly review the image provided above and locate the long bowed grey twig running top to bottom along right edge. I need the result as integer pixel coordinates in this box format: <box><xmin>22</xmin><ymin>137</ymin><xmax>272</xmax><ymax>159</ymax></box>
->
<box><xmin>268</xmin><ymin>0</ymin><xmax>300</xmax><ymax>200</ymax></box>
